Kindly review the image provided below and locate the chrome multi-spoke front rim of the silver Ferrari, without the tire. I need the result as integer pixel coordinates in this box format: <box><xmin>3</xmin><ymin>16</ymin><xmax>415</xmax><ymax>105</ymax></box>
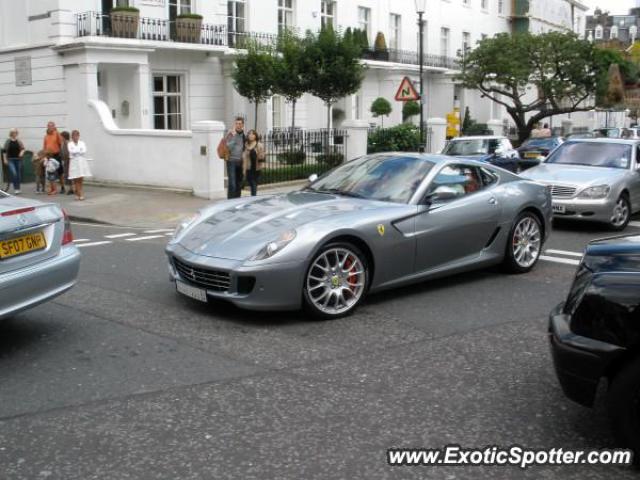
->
<box><xmin>307</xmin><ymin>247</ymin><xmax>366</xmax><ymax>315</ymax></box>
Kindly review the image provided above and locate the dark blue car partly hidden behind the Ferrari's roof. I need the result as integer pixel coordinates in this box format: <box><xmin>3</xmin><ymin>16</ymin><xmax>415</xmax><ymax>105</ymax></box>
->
<box><xmin>442</xmin><ymin>135</ymin><xmax>518</xmax><ymax>172</ymax></box>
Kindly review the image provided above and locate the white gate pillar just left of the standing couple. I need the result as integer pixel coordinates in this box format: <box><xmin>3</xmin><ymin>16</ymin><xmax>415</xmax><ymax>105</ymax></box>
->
<box><xmin>191</xmin><ymin>121</ymin><xmax>225</xmax><ymax>199</ymax></box>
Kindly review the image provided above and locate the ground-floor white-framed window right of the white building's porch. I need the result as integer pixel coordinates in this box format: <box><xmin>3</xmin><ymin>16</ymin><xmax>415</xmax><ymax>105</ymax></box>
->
<box><xmin>153</xmin><ymin>74</ymin><xmax>184</xmax><ymax>130</ymax></box>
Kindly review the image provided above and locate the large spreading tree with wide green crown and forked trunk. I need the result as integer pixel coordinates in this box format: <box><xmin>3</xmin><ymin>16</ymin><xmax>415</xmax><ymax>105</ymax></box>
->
<box><xmin>457</xmin><ymin>32</ymin><xmax>602</xmax><ymax>141</ymax></box>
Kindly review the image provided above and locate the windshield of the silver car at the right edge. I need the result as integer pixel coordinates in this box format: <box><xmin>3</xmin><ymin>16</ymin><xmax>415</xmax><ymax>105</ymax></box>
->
<box><xmin>545</xmin><ymin>142</ymin><xmax>631</xmax><ymax>168</ymax></box>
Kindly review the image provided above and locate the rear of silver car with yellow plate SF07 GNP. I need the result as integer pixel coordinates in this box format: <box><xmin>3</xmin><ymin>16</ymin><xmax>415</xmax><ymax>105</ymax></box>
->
<box><xmin>0</xmin><ymin>192</ymin><xmax>80</xmax><ymax>319</ymax></box>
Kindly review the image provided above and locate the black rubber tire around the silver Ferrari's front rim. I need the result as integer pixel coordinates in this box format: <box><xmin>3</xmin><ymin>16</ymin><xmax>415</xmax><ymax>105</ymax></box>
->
<box><xmin>302</xmin><ymin>242</ymin><xmax>369</xmax><ymax>320</ymax></box>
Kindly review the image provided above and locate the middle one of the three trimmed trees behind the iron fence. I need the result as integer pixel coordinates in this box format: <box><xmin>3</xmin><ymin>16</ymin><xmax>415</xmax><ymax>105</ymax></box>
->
<box><xmin>273</xmin><ymin>31</ymin><xmax>308</xmax><ymax>132</ymax></box>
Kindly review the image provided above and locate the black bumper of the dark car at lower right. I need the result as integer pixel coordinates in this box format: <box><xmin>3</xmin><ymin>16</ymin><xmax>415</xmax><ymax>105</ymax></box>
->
<box><xmin>549</xmin><ymin>304</ymin><xmax>625</xmax><ymax>407</ymax></box>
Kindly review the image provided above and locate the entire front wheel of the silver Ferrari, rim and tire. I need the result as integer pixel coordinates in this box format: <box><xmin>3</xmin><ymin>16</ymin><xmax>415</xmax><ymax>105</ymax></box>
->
<box><xmin>303</xmin><ymin>243</ymin><xmax>369</xmax><ymax>319</ymax></box>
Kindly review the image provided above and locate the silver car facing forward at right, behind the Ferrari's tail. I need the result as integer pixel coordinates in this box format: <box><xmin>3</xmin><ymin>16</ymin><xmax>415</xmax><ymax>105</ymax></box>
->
<box><xmin>522</xmin><ymin>138</ymin><xmax>640</xmax><ymax>230</ymax></box>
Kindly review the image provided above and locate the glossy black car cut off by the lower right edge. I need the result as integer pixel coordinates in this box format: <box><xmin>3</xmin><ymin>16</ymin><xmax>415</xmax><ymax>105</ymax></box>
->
<box><xmin>549</xmin><ymin>235</ymin><xmax>640</xmax><ymax>463</ymax></box>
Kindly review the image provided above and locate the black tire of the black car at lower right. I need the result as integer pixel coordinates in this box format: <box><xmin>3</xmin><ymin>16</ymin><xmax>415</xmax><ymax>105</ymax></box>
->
<box><xmin>607</xmin><ymin>358</ymin><xmax>640</xmax><ymax>465</ymax></box>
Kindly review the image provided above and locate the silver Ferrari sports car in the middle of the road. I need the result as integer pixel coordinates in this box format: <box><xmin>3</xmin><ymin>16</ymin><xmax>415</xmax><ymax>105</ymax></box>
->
<box><xmin>166</xmin><ymin>153</ymin><xmax>552</xmax><ymax>318</ymax></box>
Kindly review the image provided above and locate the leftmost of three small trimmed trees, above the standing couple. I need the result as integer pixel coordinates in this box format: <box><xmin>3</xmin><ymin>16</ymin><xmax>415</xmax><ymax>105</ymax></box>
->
<box><xmin>232</xmin><ymin>42</ymin><xmax>274</xmax><ymax>130</ymax></box>
